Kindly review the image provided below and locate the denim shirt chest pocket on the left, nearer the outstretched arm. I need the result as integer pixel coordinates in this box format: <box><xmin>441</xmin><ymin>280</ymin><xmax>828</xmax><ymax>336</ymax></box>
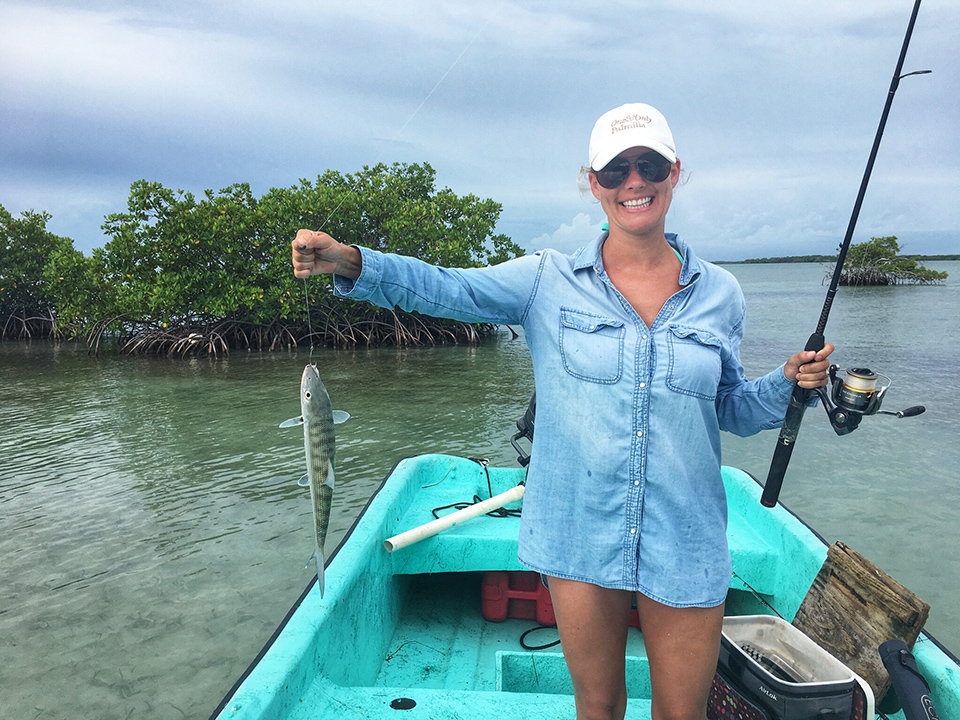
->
<box><xmin>560</xmin><ymin>308</ymin><xmax>626</xmax><ymax>384</ymax></box>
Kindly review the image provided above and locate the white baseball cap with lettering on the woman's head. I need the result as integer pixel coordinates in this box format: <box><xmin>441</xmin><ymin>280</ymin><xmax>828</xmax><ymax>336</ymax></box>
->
<box><xmin>590</xmin><ymin>103</ymin><xmax>677</xmax><ymax>170</ymax></box>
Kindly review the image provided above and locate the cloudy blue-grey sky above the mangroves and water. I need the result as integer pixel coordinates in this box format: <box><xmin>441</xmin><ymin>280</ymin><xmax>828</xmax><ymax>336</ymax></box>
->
<box><xmin>0</xmin><ymin>0</ymin><xmax>960</xmax><ymax>260</ymax></box>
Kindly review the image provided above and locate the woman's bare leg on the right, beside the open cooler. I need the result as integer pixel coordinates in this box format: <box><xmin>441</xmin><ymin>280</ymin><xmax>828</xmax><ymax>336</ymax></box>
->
<box><xmin>637</xmin><ymin>593</ymin><xmax>723</xmax><ymax>720</ymax></box>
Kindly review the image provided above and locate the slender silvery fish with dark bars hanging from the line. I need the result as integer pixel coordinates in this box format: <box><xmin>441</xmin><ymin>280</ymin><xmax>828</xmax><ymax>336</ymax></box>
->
<box><xmin>280</xmin><ymin>363</ymin><xmax>350</xmax><ymax>597</ymax></box>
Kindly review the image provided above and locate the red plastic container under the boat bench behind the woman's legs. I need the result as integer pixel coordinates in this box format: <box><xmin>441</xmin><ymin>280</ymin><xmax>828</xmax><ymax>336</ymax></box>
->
<box><xmin>480</xmin><ymin>570</ymin><xmax>640</xmax><ymax>628</ymax></box>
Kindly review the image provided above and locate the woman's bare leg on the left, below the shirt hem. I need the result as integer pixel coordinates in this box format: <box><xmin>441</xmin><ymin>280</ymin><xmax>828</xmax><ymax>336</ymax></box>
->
<box><xmin>549</xmin><ymin>578</ymin><xmax>636</xmax><ymax>720</ymax></box>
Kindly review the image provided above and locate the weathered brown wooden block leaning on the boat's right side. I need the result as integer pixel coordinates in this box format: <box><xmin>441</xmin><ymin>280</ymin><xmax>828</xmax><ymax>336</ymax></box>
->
<box><xmin>793</xmin><ymin>542</ymin><xmax>930</xmax><ymax>701</ymax></box>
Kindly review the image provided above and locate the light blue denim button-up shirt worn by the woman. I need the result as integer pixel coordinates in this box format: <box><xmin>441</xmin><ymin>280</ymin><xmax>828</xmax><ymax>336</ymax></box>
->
<box><xmin>334</xmin><ymin>233</ymin><xmax>793</xmax><ymax>607</ymax></box>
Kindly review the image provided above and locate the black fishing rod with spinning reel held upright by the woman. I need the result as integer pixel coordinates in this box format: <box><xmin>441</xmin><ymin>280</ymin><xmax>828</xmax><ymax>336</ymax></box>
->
<box><xmin>760</xmin><ymin>0</ymin><xmax>930</xmax><ymax>507</ymax></box>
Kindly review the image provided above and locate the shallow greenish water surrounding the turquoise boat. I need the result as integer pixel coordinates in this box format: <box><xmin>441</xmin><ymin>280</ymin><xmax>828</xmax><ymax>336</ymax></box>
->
<box><xmin>0</xmin><ymin>263</ymin><xmax>960</xmax><ymax>719</ymax></box>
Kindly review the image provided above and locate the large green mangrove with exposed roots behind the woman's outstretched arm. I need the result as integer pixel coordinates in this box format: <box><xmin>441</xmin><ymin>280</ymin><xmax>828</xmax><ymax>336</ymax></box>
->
<box><xmin>0</xmin><ymin>163</ymin><xmax>522</xmax><ymax>354</ymax></box>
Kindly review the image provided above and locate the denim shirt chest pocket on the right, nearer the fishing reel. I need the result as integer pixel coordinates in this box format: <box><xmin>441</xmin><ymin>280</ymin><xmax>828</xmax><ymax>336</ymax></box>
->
<box><xmin>667</xmin><ymin>325</ymin><xmax>722</xmax><ymax>400</ymax></box>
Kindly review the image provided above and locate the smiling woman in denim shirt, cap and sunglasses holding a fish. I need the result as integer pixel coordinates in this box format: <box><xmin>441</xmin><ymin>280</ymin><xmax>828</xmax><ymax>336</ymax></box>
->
<box><xmin>293</xmin><ymin>104</ymin><xmax>833</xmax><ymax>720</ymax></box>
